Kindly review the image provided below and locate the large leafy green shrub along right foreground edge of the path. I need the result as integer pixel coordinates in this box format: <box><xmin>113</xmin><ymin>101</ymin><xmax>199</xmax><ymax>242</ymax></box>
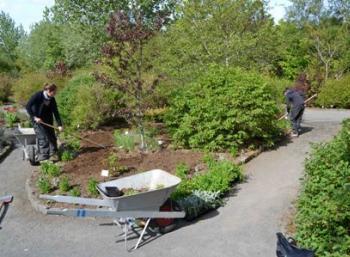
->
<box><xmin>295</xmin><ymin>120</ymin><xmax>350</xmax><ymax>257</ymax></box>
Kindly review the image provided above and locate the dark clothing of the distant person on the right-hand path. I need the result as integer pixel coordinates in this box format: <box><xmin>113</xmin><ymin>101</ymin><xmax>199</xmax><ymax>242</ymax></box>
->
<box><xmin>285</xmin><ymin>89</ymin><xmax>305</xmax><ymax>134</ymax></box>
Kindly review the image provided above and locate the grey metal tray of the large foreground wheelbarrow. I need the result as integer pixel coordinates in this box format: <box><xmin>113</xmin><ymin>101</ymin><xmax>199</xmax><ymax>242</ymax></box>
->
<box><xmin>98</xmin><ymin>169</ymin><xmax>181</xmax><ymax>211</ymax></box>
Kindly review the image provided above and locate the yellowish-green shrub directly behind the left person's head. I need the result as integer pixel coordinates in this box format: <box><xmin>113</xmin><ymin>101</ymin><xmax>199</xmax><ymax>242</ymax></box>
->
<box><xmin>13</xmin><ymin>73</ymin><xmax>48</xmax><ymax>105</ymax></box>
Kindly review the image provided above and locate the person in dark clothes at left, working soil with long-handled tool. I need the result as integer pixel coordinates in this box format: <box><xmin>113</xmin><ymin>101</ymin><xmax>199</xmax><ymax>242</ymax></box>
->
<box><xmin>26</xmin><ymin>84</ymin><xmax>63</xmax><ymax>162</ymax></box>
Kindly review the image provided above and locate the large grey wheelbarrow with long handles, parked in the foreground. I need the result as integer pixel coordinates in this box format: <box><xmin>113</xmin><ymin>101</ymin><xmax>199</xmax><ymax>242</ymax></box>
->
<box><xmin>40</xmin><ymin>169</ymin><xmax>185</xmax><ymax>249</ymax></box>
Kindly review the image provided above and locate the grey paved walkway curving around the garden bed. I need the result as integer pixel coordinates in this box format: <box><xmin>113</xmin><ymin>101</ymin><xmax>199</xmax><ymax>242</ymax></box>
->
<box><xmin>0</xmin><ymin>109</ymin><xmax>350</xmax><ymax>257</ymax></box>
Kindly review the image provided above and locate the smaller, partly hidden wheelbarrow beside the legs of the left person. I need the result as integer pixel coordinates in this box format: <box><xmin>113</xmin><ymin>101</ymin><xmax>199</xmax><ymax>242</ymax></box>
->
<box><xmin>14</xmin><ymin>127</ymin><xmax>39</xmax><ymax>165</ymax></box>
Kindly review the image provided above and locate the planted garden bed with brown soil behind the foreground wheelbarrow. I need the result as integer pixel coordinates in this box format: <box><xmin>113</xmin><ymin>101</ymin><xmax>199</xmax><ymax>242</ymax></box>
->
<box><xmin>29</xmin><ymin>125</ymin><xmax>252</xmax><ymax>214</ymax></box>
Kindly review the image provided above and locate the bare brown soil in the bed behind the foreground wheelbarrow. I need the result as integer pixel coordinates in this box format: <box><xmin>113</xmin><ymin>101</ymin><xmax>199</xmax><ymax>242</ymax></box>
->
<box><xmin>42</xmin><ymin>128</ymin><xmax>203</xmax><ymax>197</ymax></box>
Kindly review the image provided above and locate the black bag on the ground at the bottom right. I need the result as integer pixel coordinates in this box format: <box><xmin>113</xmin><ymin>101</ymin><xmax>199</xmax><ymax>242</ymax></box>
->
<box><xmin>276</xmin><ymin>233</ymin><xmax>315</xmax><ymax>257</ymax></box>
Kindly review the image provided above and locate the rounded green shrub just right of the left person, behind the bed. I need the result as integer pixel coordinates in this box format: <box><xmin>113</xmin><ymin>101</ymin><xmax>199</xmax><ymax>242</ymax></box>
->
<box><xmin>57</xmin><ymin>71</ymin><xmax>121</xmax><ymax>129</ymax></box>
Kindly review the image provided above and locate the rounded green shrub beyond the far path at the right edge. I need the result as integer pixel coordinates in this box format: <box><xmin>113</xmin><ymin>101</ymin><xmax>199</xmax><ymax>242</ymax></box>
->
<box><xmin>316</xmin><ymin>75</ymin><xmax>350</xmax><ymax>109</ymax></box>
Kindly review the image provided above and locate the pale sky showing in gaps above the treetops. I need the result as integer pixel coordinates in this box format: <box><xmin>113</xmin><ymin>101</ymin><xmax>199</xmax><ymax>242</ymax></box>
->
<box><xmin>0</xmin><ymin>0</ymin><xmax>289</xmax><ymax>32</ymax></box>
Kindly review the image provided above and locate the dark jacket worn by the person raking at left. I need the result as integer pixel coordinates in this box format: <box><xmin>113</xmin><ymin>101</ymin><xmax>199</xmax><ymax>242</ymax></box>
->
<box><xmin>26</xmin><ymin>91</ymin><xmax>62</xmax><ymax>126</ymax></box>
